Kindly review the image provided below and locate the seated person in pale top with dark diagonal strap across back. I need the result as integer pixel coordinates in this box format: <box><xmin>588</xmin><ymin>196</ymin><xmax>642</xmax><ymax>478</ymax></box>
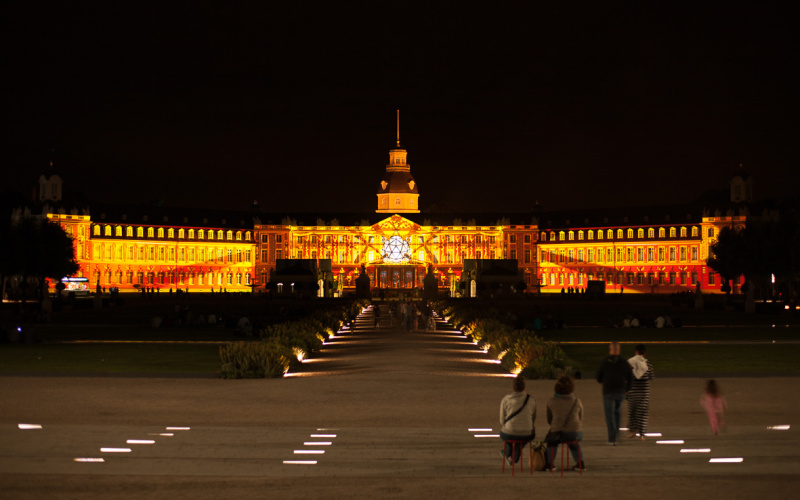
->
<box><xmin>500</xmin><ymin>377</ymin><xmax>536</xmax><ymax>466</ymax></box>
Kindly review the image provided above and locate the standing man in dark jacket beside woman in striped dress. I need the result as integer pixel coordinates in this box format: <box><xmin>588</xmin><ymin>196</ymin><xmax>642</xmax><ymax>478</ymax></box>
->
<box><xmin>596</xmin><ymin>342</ymin><xmax>633</xmax><ymax>446</ymax></box>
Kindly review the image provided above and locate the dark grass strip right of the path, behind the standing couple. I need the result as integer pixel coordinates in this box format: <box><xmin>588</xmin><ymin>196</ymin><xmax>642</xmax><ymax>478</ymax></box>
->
<box><xmin>562</xmin><ymin>344</ymin><xmax>800</xmax><ymax>378</ymax></box>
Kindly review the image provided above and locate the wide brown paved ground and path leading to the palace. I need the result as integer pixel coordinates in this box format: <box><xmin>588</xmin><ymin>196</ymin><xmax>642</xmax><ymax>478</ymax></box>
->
<box><xmin>0</xmin><ymin>302</ymin><xmax>800</xmax><ymax>498</ymax></box>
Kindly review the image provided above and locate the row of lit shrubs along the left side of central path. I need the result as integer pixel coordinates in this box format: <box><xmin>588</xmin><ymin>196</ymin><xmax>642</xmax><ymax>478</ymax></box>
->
<box><xmin>219</xmin><ymin>300</ymin><xmax>368</xmax><ymax>378</ymax></box>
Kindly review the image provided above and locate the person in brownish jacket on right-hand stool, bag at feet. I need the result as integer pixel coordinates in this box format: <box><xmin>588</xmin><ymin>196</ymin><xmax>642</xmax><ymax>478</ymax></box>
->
<box><xmin>545</xmin><ymin>377</ymin><xmax>586</xmax><ymax>470</ymax></box>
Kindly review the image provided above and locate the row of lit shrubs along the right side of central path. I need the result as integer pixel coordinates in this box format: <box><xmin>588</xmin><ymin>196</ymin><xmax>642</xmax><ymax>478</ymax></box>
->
<box><xmin>433</xmin><ymin>301</ymin><xmax>576</xmax><ymax>379</ymax></box>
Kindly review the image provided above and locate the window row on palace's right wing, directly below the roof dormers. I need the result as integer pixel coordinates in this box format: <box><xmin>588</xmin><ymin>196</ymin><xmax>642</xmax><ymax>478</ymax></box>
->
<box><xmin>536</xmin><ymin>246</ymin><xmax>699</xmax><ymax>264</ymax></box>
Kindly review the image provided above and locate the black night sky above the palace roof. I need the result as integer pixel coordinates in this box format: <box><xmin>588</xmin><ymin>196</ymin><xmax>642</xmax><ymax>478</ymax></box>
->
<box><xmin>0</xmin><ymin>1</ymin><xmax>800</xmax><ymax>212</ymax></box>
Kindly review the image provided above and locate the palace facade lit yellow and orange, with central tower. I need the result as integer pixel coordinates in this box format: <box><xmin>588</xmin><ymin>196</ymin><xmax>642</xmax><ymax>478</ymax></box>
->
<box><xmin>48</xmin><ymin>127</ymin><xmax>752</xmax><ymax>294</ymax></box>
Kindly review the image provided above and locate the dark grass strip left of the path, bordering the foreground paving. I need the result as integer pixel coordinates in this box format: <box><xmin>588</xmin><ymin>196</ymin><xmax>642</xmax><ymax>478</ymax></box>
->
<box><xmin>0</xmin><ymin>344</ymin><xmax>220</xmax><ymax>375</ymax></box>
